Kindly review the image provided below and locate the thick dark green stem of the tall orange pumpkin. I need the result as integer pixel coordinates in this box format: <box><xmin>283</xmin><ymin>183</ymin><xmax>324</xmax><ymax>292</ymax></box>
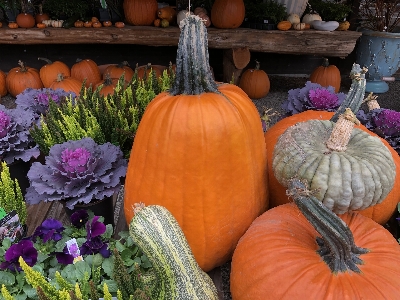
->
<box><xmin>169</xmin><ymin>15</ymin><xmax>218</xmax><ymax>96</ymax></box>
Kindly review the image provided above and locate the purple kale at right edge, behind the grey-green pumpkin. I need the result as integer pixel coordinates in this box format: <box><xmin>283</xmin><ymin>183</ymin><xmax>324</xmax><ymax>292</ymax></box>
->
<box><xmin>357</xmin><ymin>108</ymin><xmax>400</xmax><ymax>154</ymax></box>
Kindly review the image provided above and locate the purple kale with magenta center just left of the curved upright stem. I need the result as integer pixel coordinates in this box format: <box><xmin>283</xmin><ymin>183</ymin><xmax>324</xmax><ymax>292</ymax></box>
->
<box><xmin>282</xmin><ymin>81</ymin><xmax>346</xmax><ymax>116</ymax></box>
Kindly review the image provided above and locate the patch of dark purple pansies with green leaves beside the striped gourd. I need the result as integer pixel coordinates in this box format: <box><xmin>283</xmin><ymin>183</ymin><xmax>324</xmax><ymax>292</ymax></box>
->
<box><xmin>0</xmin><ymin>210</ymin><xmax>151</xmax><ymax>299</ymax></box>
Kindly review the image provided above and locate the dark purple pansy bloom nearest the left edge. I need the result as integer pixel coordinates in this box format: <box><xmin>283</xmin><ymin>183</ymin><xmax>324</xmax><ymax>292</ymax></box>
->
<box><xmin>0</xmin><ymin>240</ymin><xmax>38</xmax><ymax>272</ymax></box>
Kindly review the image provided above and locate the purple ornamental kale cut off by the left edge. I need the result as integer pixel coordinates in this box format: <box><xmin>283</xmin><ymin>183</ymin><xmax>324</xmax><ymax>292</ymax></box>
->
<box><xmin>0</xmin><ymin>105</ymin><xmax>40</xmax><ymax>164</ymax></box>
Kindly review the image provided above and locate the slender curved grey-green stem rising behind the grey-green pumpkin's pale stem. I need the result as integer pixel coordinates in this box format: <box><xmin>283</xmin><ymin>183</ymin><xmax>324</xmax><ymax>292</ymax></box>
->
<box><xmin>331</xmin><ymin>64</ymin><xmax>368</xmax><ymax>122</ymax></box>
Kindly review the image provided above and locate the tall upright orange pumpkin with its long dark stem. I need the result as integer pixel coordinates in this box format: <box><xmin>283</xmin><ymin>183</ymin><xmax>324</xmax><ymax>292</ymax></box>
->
<box><xmin>124</xmin><ymin>15</ymin><xmax>268</xmax><ymax>272</ymax></box>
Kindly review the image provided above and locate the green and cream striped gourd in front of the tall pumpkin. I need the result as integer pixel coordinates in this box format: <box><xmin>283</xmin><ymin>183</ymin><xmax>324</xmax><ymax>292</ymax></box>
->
<box><xmin>129</xmin><ymin>205</ymin><xmax>218</xmax><ymax>300</ymax></box>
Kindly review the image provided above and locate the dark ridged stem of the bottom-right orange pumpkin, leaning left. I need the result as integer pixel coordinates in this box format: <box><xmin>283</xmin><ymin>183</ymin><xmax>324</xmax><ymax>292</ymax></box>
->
<box><xmin>286</xmin><ymin>178</ymin><xmax>369</xmax><ymax>273</ymax></box>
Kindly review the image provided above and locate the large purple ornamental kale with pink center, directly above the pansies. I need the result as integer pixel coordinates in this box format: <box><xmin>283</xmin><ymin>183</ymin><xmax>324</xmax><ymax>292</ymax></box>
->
<box><xmin>25</xmin><ymin>138</ymin><xmax>127</xmax><ymax>209</ymax></box>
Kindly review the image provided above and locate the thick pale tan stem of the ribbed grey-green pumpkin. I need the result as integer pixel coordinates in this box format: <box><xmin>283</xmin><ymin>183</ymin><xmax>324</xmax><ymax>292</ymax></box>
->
<box><xmin>326</xmin><ymin>108</ymin><xmax>360</xmax><ymax>151</ymax></box>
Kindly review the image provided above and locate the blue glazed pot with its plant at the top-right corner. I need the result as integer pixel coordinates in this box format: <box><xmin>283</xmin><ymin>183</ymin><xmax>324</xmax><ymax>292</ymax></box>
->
<box><xmin>356</xmin><ymin>0</ymin><xmax>400</xmax><ymax>93</ymax></box>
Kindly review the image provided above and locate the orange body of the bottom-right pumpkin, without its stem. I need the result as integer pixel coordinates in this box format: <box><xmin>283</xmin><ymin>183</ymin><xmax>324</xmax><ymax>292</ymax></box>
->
<box><xmin>230</xmin><ymin>203</ymin><xmax>400</xmax><ymax>300</ymax></box>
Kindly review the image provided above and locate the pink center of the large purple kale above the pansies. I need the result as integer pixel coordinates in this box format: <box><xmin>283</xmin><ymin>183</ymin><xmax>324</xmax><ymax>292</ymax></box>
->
<box><xmin>61</xmin><ymin>148</ymin><xmax>91</xmax><ymax>174</ymax></box>
